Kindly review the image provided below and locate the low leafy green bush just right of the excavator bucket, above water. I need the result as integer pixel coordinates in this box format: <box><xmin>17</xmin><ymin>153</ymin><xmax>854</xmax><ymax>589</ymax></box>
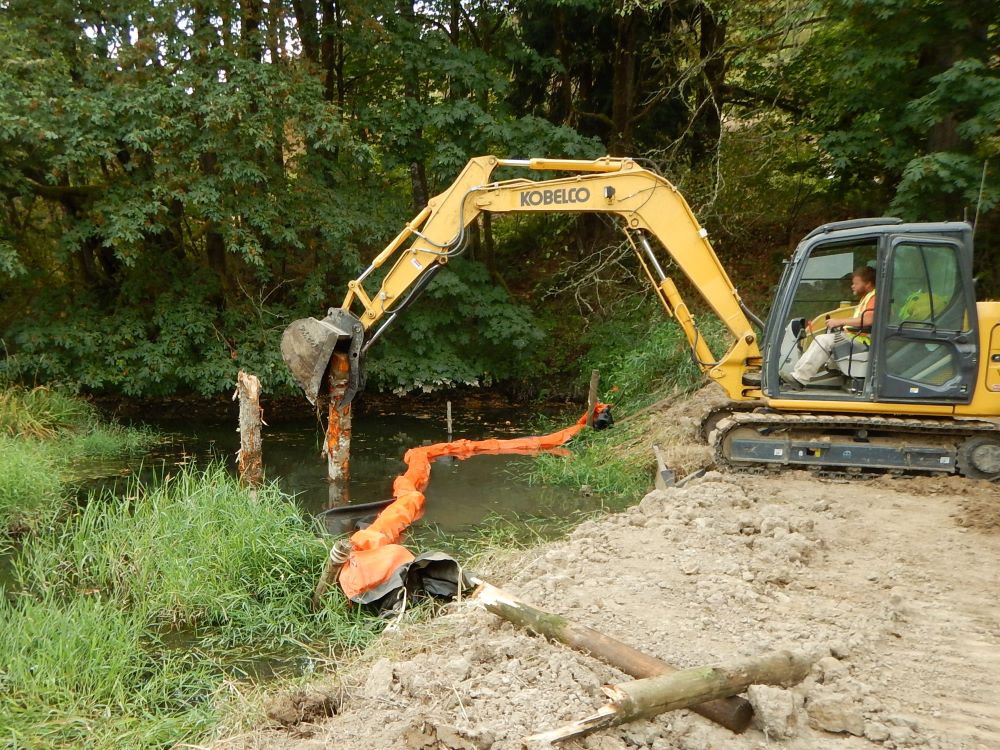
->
<box><xmin>369</xmin><ymin>258</ymin><xmax>542</xmax><ymax>392</ymax></box>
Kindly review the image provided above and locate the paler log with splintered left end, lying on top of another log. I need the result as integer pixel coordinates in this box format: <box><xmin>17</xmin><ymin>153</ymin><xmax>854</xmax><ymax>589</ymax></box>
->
<box><xmin>525</xmin><ymin>651</ymin><xmax>812</xmax><ymax>744</ymax></box>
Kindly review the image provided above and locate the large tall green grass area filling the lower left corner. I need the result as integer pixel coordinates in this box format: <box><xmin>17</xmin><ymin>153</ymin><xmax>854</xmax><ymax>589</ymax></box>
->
<box><xmin>0</xmin><ymin>466</ymin><xmax>378</xmax><ymax>748</ymax></box>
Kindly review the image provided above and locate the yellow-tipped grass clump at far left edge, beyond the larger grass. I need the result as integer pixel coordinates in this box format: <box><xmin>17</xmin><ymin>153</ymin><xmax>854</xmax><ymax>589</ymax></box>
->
<box><xmin>0</xmin><ymin>385</ymin><xmax>155</xmax><ymax>535</ymax></box>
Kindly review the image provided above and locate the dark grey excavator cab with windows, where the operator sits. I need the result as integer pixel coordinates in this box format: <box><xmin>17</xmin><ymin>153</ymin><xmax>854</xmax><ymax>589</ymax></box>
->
<box><xmin>764</xmin><ymin>218</ymin><xmax>979</xmax><ymax>404</ymax></box>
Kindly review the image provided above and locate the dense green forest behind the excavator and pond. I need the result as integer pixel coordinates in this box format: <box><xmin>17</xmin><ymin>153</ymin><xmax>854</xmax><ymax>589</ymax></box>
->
<box><xmin>0</xmin><ymin>0</ymin><xmax>1000</xmax><ymax>398</ymax></box>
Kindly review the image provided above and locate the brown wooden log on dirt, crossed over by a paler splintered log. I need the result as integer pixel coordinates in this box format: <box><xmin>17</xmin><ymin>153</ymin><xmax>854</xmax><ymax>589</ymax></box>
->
<box><xmin>472</xmin><ymin>582</ymin><xmax>753</xmax><ymax>734</ymax></box>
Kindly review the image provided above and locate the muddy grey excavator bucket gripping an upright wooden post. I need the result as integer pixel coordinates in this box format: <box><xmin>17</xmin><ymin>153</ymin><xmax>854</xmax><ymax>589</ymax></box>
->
<box><xmin>281</xmin><ymin>308</ymin><xmax>364</xmax><ymax>406</ymax></box>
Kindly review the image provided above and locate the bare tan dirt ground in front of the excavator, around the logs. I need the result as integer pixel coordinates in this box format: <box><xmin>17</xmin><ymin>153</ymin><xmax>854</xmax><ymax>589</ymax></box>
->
<box><xmin>227</xmin><ymin>400</ymin><xmax>1000</xmax><ymax>750</ymax></box>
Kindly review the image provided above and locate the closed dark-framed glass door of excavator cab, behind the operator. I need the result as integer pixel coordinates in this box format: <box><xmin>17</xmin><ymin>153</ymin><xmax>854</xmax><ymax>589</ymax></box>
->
<box><xmin>873</xmin><ymin>235</ymin><xmax>979</xmax><ymax>404</ymax></box>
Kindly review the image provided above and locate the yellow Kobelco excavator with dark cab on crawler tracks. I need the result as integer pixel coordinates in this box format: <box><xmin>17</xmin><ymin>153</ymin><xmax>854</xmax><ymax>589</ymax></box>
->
<box><xmin>281</xmin><ymin>156</ymin><xmax>1000</xmax><ymax>480</ymax></box>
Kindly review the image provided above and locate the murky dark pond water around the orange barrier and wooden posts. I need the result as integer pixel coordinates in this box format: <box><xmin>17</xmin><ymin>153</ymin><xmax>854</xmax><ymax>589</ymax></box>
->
<box><xmin>112</xmin><ymin>406</ymin><xmax>601</xmax><ymax>534</ymax></box>
